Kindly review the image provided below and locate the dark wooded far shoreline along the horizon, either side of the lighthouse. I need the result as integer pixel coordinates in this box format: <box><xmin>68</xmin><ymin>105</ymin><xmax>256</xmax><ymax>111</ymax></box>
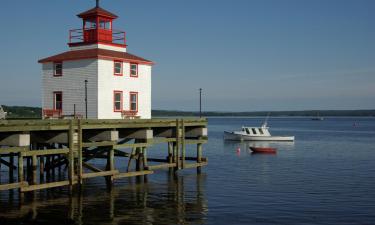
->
<box><xmin>3</xmin><ymin>105</ymin><xmax>375</xmax><ymax>119</ymax></box>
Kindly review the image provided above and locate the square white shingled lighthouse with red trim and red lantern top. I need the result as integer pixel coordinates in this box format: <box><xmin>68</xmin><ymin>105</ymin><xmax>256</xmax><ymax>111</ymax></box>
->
<box><xmin>39</xmin><ymin>0</ymin><xmax>154</xmax><ymax>119</ymax></box>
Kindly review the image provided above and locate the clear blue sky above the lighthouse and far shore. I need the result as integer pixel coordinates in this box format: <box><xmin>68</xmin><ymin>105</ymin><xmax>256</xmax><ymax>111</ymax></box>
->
<box><xmin>0</xmin><ymin>0</ymin><xmax>375</xmax><ymax>111</ymax></box>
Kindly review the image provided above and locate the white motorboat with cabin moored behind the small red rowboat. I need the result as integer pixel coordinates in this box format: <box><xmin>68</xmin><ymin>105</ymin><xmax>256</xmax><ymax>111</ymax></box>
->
<box><xmin>224</xmin><ymin>122</ymin><xmax>294</xmax><ymax>141</ymax></box>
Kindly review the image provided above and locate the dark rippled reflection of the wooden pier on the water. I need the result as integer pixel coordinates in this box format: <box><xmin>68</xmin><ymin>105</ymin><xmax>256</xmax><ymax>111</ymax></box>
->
<box><xmin>0</xmin><ymin>171</ymin><xmax>208</xmax><ymax>224</ymax></box>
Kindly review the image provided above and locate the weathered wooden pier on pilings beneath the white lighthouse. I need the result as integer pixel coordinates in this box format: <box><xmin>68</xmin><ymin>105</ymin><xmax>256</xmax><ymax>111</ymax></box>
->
<box><xmin>0</xmin><ymin>118</ymin><xmax>207</xmax><ymax>192</ymax></box>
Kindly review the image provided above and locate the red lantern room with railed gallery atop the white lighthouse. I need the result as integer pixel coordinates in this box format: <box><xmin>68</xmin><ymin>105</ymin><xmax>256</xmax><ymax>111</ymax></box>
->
<box><xmin>69</xmin><ymin>1</ymin><xmax>126</xmax><ymax>47</ymax></box>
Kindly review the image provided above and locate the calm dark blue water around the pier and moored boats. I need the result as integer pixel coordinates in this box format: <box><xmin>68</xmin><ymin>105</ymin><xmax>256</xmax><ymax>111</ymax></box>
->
<box><xmin>0</xmin><ymin>118</ymin><xmax>375</xmax><ymax>225</ymax></box>
